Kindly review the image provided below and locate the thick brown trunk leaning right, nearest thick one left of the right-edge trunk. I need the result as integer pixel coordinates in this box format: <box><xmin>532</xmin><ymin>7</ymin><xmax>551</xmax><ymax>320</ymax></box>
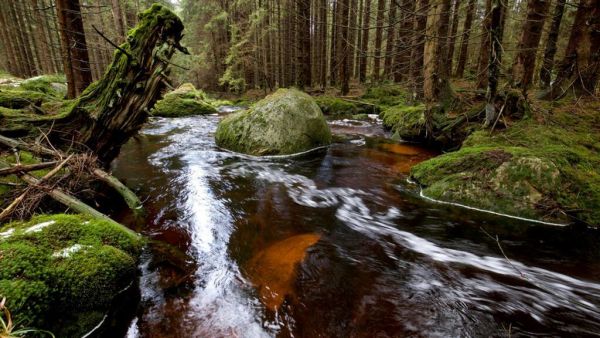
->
<box><xmin>511</xmin><ymin>0</ymin><xmax>550</xmax><ymax>92</ymax></box>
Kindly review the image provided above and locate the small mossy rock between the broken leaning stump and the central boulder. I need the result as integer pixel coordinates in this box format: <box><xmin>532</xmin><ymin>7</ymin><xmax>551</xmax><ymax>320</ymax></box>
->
<box><xmin>152</xmin><ymin>83</ymin><xmax>217</xmax><ymax>117</ymax></box>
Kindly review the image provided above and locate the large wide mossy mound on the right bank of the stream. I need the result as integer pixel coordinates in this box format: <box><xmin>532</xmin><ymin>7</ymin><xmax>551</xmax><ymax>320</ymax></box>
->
<box><xmin>411</xmin><ymin>102</ymin><xmax>600</xmax><ymax>226</ymax></box>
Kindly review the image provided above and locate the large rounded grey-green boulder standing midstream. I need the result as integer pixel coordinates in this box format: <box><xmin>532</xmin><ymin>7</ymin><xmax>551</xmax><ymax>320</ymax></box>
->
<box><xmin>215</xmin><ymin>89</ymin><xmax>331</xmax><ymax>155</ymax></box>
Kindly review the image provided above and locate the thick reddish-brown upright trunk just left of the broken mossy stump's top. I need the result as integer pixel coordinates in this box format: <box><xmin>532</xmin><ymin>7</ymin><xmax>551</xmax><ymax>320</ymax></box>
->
<box><xmin>56</xmin><ymin>0</ymin><xmax>92</xmax><ymax>98</ymax></box>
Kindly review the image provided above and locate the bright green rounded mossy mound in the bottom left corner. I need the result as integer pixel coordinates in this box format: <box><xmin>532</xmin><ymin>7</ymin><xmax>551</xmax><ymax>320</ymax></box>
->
<box><xmin>0</xmin><ymin>214</ymin><xmax>142</xmax><ymax>337</ymax></box>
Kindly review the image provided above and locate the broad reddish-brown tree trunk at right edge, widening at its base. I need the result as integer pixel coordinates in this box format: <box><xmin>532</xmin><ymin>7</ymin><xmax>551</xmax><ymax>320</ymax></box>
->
<box><xmin>544</xmin><ymin>0</ymin><xmax>600</xmax><ymax>99</ymax></box>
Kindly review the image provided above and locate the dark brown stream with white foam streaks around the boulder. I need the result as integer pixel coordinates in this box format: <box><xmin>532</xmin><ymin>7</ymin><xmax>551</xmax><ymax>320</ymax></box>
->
<box><xmin>113</xmin><ymin>110</ymin><xmax>600</xmax><ymax>337</ymax></box>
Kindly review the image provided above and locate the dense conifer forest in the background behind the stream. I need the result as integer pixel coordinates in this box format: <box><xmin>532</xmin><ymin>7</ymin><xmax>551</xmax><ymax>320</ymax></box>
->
<box><xmin>0</xmin><ymin>0</ymin><xmax>599</xmax><ymax>99</ymax></box>
